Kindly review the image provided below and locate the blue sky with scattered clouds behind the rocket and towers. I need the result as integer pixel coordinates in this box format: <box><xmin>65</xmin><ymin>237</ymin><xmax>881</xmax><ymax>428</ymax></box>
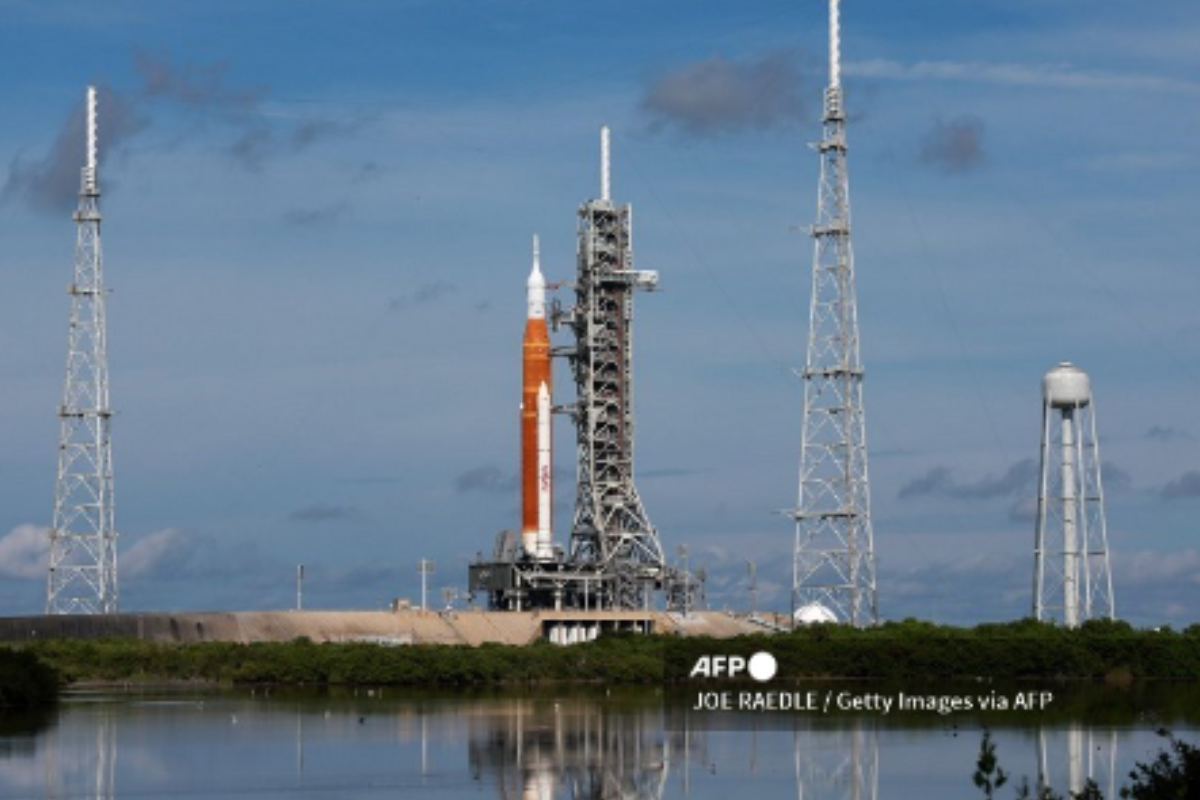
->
<box><xmin>0</xmin><ymin>0</ymin><xmax>1200</xmax><ymax>626</ymax></box>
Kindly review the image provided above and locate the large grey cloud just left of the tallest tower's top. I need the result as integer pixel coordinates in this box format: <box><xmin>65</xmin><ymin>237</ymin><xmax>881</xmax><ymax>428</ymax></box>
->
<box><xmin>641</xmin><ymin>53</ymin><xmax>806</xmax><ymax>137</ymax></box>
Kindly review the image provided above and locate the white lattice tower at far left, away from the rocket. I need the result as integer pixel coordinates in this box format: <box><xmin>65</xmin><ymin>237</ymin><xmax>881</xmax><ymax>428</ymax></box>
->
<box><xmin>46</xmin><ymin>86</ymin><xmax>116</xmax><ymax>614</ymax></box>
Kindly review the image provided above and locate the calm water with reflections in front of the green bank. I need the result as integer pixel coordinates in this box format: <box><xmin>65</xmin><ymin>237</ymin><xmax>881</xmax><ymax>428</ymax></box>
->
<box><xmin>0</xmin><ymin>685</ymin><xmax>1200</xmax><ymax>800</ymax></box>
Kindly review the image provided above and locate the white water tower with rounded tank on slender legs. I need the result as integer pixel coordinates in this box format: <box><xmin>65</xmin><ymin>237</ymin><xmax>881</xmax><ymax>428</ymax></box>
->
<box><xmin>1033</xmin><ymin>361</ymin><xmax>1115</xmax><ymax>627</ymax></box>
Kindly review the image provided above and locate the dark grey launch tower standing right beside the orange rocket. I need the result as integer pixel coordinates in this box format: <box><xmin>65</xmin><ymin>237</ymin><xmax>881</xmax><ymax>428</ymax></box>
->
<box><xmin>556</xmin><ymin>127</ymin><xmax>665</xmax><ymax>608</ymax></box>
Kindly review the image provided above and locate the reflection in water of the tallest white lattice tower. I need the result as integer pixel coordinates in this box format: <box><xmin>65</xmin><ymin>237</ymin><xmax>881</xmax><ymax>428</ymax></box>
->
<box><xmin>794</xmin><ymin>720</ymin><xmax>880</xmax><ymax>800</ymax></box>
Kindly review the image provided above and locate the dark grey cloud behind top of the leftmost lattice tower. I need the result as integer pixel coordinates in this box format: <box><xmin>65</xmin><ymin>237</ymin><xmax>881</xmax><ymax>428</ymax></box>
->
<box><xmin>0</xmin><ymin>85</ymin><xmax>149</xmax><ymax>215</ymax></box>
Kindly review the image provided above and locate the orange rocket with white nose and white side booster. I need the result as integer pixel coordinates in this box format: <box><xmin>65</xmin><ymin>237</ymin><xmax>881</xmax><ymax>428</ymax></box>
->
<box><xmin>521</xmin><ymin>236</ymin><xmax>554</xmax><ymax>560</ymax></box>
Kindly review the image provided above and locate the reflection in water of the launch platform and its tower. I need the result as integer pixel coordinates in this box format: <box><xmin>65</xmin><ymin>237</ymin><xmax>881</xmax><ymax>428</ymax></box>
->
<box><xmin>468</xmin><ymin>698</ymin><xmax>671</xmax><ymax>800</ymax></box>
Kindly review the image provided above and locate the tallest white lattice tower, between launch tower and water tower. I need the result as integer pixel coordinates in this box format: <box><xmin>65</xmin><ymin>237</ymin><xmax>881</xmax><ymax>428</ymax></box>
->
<box><xmin>792</xmin><ymin>0</ymin><xmax>878</xmax><ymax>626</ymax></box>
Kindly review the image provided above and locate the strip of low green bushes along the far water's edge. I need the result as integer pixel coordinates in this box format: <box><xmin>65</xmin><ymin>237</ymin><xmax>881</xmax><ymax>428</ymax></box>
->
<box><xmin>9</xmin><ymin>620</ymin><xmax>1200</xmax><ymax>686</ymax></box>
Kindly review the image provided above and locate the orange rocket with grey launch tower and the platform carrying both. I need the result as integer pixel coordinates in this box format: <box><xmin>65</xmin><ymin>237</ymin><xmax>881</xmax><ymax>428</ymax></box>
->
<box><xmin>468</xmin><ymin>128</ymin><xmax>703</xmax><ymax>612</ymax></box>
